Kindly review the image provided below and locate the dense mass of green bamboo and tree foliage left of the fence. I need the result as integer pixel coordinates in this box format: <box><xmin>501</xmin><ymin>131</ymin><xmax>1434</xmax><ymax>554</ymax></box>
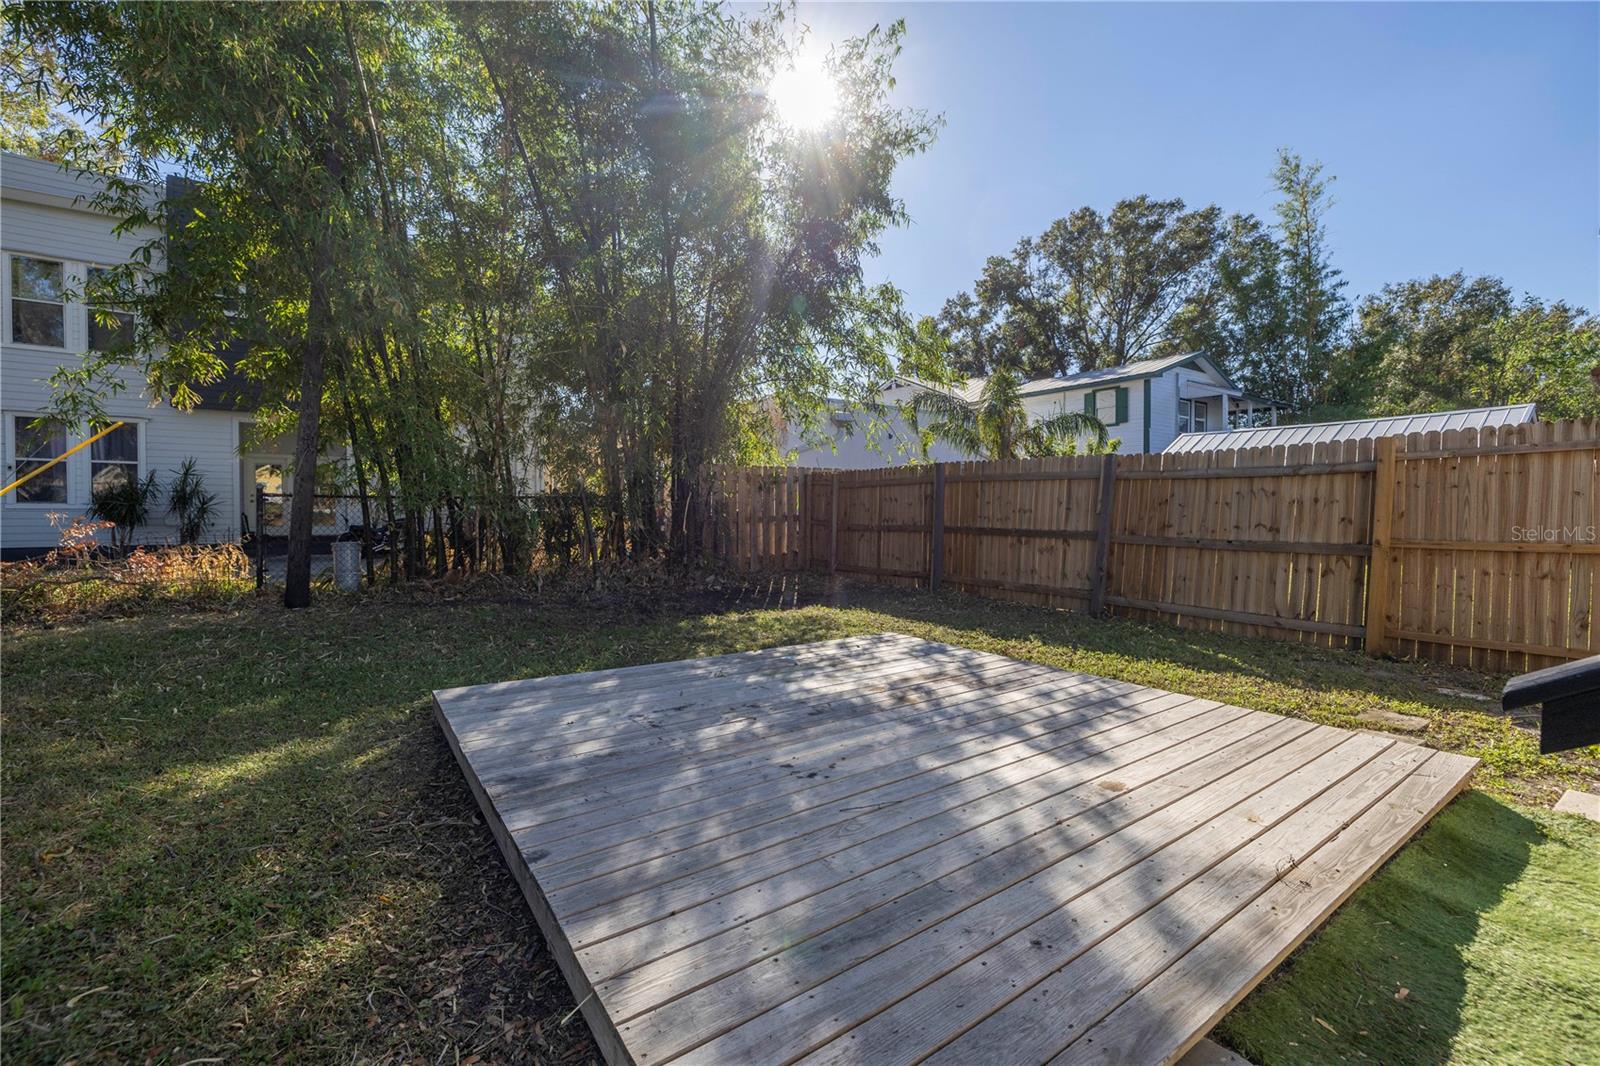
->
<box><xmin>5</xmin><ymin>3</ymin><xmax>938</xmax><ymax>589</ymax></box>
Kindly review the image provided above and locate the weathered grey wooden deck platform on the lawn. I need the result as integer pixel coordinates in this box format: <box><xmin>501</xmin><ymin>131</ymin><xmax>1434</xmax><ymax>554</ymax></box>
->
<box><xmin>435</xmin><ymin>634</ymin><xmax>1475</xmax><ymax>1066</ymax></box>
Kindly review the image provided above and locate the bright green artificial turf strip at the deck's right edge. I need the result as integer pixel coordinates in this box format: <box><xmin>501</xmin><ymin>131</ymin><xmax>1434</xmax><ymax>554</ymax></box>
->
<box><xmin>1218</xmin><ymin>792</ymin><xmax>1600</xmax><ymax>1066</ymax></box>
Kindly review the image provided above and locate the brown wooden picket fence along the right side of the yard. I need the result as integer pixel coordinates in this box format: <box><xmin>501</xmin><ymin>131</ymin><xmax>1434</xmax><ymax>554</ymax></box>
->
<box><xmin>706</xmin><ymin>421</ymin><xmax>1600</xmax><ymax>672</ymax></box>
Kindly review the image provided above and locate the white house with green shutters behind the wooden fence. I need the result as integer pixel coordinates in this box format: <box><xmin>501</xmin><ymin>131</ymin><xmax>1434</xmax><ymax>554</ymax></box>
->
<box><xmin>779</xmin><ymin>354</ymin><xmax>1278</xmax><ymax>469</ymax></box>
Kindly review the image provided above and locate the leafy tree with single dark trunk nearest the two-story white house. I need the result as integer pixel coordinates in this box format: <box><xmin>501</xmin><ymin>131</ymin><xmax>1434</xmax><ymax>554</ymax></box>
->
<box><xmin>6</xmin><ymin>3</ymin><xmax>405</xmax><ymax>607</ymax></box>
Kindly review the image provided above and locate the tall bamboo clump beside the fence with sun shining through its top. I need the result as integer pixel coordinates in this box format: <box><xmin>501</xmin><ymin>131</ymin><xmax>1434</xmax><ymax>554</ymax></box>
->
<box><xmin>461</xmin><ymin>5</ymin><xmax>933</xmax><ymax>551</ymax></box>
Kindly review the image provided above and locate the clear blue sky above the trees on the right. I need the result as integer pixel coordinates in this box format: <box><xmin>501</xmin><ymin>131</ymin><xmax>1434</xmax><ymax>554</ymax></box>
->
<box><xmin>780</xmin><ymin>3</ymin><xmax>1600</xmax><ymax>320</ymax></box>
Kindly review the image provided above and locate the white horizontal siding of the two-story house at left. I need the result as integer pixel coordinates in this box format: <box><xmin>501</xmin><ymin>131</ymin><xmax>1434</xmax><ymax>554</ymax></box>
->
<box><xmin>0</xmin><ymin>154</ymin><xmax>240</xmax><ymax>555</ymax></box>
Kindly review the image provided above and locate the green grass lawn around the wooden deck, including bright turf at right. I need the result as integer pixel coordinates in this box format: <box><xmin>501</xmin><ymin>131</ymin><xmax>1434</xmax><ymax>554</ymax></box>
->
<box><xmin>0</xmin><ymin>576</ymin><xmax>1600</xmax><ymax>1063</ymax></box>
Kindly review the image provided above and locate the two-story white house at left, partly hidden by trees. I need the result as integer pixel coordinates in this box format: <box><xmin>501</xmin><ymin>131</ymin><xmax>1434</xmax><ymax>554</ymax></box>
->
<box><xmin>0</xmin><ymin>152</ymin><xmax>315</xmax><ymax>557</ymax></box>
